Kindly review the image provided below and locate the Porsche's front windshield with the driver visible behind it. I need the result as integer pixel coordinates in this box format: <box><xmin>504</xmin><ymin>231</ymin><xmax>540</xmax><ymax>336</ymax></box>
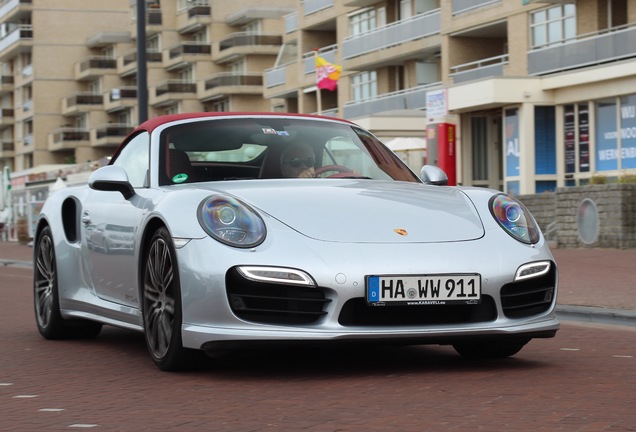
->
<box><xmin>159</xmin><ymin>116</ymin><xmax>420</xmax><ymax>185</ymax></box>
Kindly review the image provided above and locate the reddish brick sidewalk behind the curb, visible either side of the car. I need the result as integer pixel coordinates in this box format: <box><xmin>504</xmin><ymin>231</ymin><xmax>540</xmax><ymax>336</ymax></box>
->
<box><xmin>0</xmin><ymin>242</ymin><xmax>636</xmax><ymax>325</ymax></box>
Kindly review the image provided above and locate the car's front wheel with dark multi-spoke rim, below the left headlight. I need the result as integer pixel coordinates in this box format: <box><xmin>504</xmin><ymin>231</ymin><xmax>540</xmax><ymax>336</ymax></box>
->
<box><xmin>142</xmin><ymin>227</ymin><xmax>197</xmax><ymax>371</ymax></box>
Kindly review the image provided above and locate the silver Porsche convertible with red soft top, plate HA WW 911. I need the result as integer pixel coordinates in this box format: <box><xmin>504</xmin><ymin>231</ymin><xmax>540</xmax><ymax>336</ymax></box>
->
<box><xmin>34</xmin><ymin>113</ymin><xmax>559</xmax><ymax>370</ymax></box>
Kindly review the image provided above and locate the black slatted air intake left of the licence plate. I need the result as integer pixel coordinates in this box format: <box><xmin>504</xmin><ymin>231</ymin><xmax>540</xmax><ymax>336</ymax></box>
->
<box><xmin>226</xmin><ymin>269</ymin><xmax>331</xmax><ymax>324</ymax></box>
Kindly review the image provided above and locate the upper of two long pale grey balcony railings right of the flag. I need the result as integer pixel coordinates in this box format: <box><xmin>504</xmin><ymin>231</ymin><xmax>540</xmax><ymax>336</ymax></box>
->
<box><xmin>342</xmin><ymin>9</ymin><xmax>441</xmax><ymax>59</ymax></box>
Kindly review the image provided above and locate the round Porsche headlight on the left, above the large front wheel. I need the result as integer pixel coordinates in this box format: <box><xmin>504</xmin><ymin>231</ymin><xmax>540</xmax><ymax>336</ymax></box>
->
<box><xmin>197</xmin><ymin>195</ymin><xmax>266</xmax><ymax>248</ymax></box>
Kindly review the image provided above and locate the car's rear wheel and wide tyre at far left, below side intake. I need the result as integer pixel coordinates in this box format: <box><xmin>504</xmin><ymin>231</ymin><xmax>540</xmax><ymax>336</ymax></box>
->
<box><xmin>33</xmin><ymin>226</ymin><xmax>102</xmax><ymax>339</ymax></box>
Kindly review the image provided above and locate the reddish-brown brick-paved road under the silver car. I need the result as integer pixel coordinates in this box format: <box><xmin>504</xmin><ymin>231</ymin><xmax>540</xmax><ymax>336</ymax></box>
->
<box><xmin>0</xmin><ymin>260</ymin><xmax>636</xmax><ymax>432</ymax></box>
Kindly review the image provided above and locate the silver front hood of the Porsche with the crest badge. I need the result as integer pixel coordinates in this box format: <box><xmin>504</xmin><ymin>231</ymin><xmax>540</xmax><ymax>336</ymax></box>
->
<box><xmin>204</xmin><ymin>179</ymin><xmax>484</xmax><ymax>243</ymax></box>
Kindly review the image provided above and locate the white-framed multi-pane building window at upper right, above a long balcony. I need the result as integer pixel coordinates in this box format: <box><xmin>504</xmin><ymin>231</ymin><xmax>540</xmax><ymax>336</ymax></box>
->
<box><xmin>530</xmin><ymin>4</ymin><xmax>576</xmax><ymax>48</ymax></box>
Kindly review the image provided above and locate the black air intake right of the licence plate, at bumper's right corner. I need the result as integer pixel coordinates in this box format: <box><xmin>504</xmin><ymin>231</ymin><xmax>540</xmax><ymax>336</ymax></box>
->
<box><xmin>501</xmin><ymin>264</ymin><xmax>556</xmax><ymax>318</ymax></box>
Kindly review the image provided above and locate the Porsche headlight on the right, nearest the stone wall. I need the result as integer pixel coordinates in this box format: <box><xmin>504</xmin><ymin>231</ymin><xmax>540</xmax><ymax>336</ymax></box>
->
<box><xmin>488</xmin><ymin>194</ymin><xmax>539</xmax><ymax>244</ymax></box>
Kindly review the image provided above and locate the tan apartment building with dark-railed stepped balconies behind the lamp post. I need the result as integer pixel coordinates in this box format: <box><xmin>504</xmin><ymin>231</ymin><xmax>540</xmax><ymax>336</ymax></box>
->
<box><xmin>0</xmin><ymin>0</ymin><xmax>296</xmax><ymax>176</ymax></box>
